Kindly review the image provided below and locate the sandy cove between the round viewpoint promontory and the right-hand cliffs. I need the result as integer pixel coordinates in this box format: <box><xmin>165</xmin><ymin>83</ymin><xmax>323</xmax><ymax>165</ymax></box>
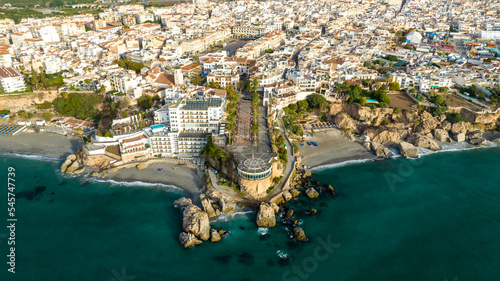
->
<box><xmin>297</xmin><ymin>129</ymin><xmax>376</xmax><ymax>168</ymax></box>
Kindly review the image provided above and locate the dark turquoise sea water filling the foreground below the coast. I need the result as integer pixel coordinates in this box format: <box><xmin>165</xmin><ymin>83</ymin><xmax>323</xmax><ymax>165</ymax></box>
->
<box><xmin>0</xmin><ymin>148</ymin><xmax>500</xmax><ymax>281</ymax></box>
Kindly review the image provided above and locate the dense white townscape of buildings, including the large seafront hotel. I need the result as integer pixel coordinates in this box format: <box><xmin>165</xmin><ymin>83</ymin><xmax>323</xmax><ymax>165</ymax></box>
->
<box><xmin>0</xmin><ymin>0</ymin><xmax>500</xmax><ymax>162</ymax></box>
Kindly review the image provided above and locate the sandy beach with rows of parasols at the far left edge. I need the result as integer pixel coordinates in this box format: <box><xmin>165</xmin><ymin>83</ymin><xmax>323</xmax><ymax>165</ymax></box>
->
<box><xmin>0</xmin><ymin>132</ymin><xmax>83</xmax><ymax>158</ymax></box>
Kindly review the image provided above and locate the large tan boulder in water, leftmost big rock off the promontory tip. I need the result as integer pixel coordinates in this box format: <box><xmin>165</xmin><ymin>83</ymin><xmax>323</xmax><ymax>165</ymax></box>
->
<box><xmin>182</xmin><ymin>204</ymin><xmax>210</xmax><ymax>240</ymax></box>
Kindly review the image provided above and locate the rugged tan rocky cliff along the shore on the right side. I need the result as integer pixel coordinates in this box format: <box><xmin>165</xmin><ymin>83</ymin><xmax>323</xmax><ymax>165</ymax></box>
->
<box><xmin>330</xmin><ymin>104</ymin><xmax>500</xmax><ymax>157</ymax></box>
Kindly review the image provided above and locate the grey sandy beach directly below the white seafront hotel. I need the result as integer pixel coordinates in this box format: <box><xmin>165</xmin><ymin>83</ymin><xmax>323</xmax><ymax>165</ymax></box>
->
<box><xmin>106</xmin><ymin>162</ymin><xmax>203</xmax><ymax>198</ymax></box>
